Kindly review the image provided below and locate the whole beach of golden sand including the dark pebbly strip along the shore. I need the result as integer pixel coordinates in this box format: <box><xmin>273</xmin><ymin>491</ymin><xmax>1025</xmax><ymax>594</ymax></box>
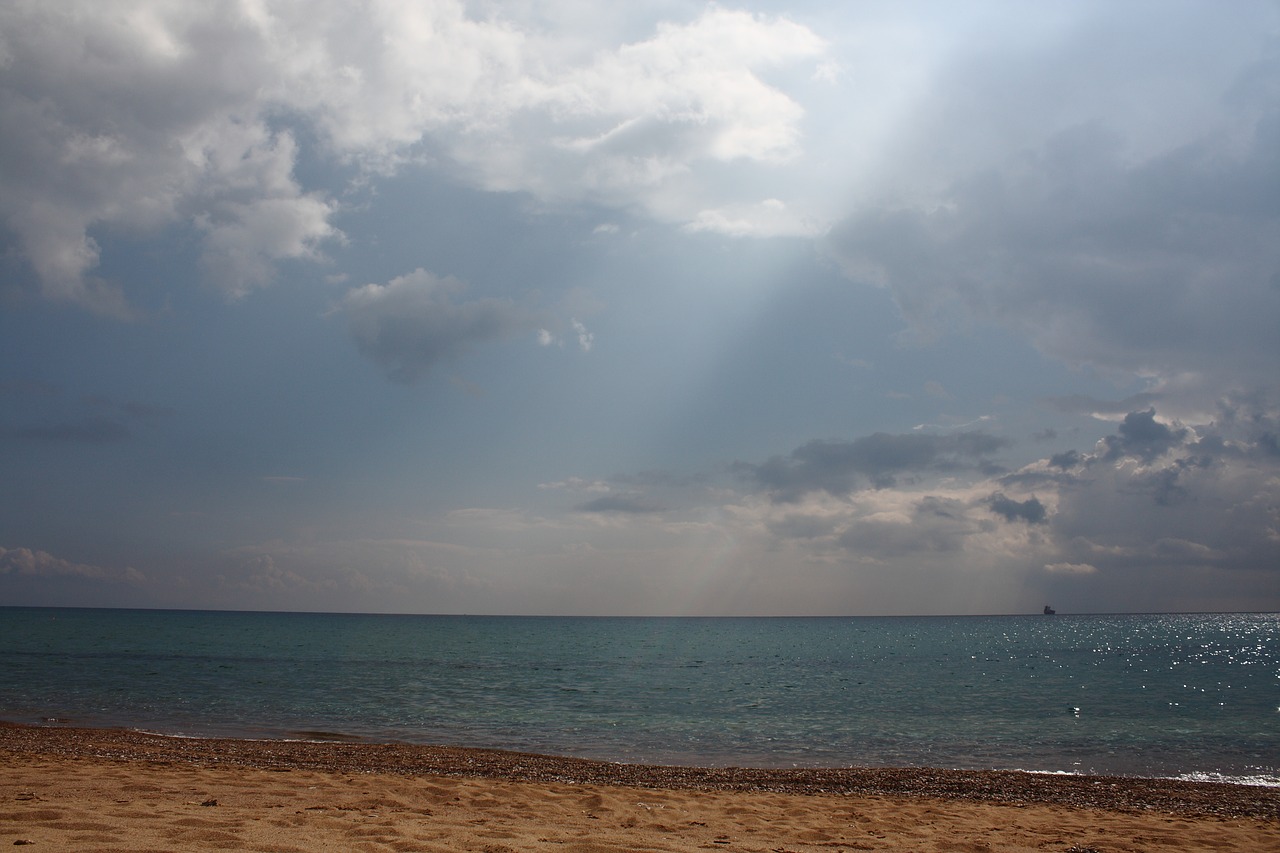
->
<box><xmin>0</xmin><ymin>725</ymin><xmax>1280</xmax><ymax>853</ymax></box>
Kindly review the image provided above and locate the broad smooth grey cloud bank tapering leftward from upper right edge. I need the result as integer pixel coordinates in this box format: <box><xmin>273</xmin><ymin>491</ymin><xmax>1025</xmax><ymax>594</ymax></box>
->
<box><xmin>831</xmin><ymin>87</ymin><xmax>1280</xmax><ymax>405</ymax></box>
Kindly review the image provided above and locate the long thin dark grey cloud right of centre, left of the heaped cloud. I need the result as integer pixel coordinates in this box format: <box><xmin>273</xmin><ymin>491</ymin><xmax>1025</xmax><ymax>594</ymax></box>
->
<box><xmin>735</xmin><ymin>432</ymin><xmax>1009</xmax><ymax>501</ymax></box>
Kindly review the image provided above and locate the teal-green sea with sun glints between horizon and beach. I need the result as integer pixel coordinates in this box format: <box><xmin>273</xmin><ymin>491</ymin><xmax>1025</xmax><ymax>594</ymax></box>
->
<box><xmin>0</xmin><ymin>607</ymin><xmax>1280</xmax><ymax>786</ymax></box>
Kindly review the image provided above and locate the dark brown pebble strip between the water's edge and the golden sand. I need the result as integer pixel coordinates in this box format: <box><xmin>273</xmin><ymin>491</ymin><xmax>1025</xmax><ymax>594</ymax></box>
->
<box><xmin>0</xmin><ymin>722</ymin><xmax>1280</xmax><ymax>821</ymax></box>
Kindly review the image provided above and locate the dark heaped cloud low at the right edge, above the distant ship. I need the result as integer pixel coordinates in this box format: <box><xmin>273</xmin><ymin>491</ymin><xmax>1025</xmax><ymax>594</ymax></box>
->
<box><xmin>991</xmin><ymin>403</ymin><xmax>1280</xmax><ymax>588</ymax></box>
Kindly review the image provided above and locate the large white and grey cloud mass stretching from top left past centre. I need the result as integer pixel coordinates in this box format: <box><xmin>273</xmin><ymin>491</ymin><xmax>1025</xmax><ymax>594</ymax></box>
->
<box><xmin>0</xmin><ymin>0</ymin><xmax>823</xmax><ymax>315</ymax></box>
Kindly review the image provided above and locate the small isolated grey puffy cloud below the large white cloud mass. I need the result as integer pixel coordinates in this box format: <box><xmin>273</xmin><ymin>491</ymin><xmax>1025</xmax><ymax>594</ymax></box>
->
<box><xmin>338</xmin><ymin>268</ymin><xmax>536</xmax><ymax>383</ymax></box>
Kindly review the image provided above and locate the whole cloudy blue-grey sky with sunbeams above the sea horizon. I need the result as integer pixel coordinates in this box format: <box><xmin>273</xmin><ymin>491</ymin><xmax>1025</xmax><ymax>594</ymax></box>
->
<box><xmin>0</xmin><ymin>0</ymin><xmax>1280</xmax><ymax>615</ymax></box>
